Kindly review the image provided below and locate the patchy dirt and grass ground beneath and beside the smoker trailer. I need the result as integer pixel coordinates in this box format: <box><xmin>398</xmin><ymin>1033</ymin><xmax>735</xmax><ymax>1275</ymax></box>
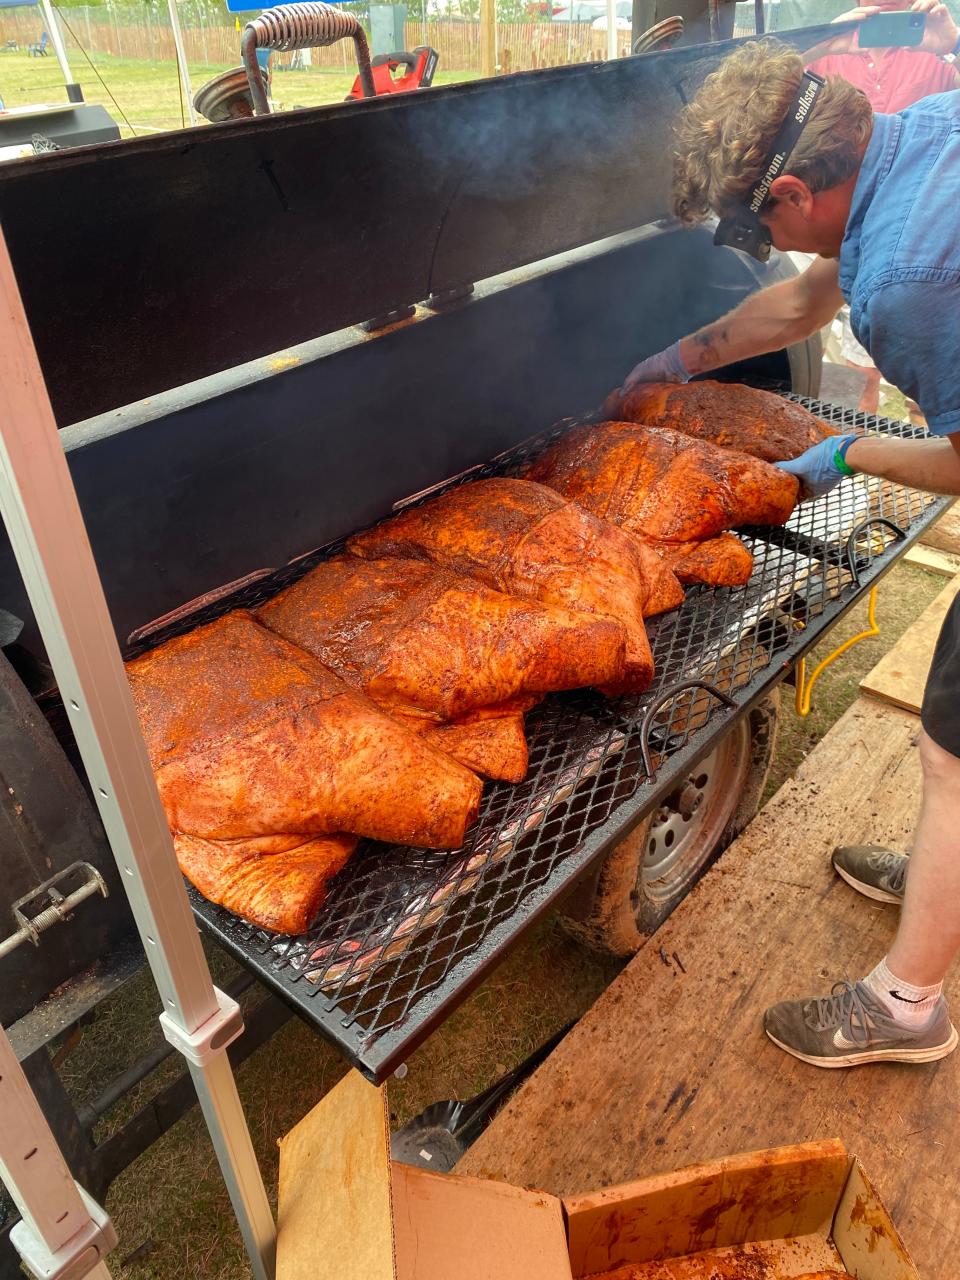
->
<box><xmin>39</xmin><ymin>552</ymin><xmax>945</xmax><ymax>1280</ymax></box>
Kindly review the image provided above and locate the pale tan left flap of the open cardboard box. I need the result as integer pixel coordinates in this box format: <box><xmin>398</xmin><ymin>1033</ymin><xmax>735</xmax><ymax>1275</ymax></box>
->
<box><xmin>276</xmin><ymin>1071</ymin><xmax>394</xmax><ymax>1280</ymax></box>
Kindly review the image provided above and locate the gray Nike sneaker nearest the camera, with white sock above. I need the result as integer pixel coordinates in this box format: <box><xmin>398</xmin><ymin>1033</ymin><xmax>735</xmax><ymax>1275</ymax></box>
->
<box><xmin>763</xmin><ymin>982</ymin><xmax>957</xmax><ymax>1066</ymax></box>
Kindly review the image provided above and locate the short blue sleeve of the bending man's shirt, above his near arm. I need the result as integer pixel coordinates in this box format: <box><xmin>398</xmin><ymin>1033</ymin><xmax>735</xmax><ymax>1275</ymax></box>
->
<box><xmin>851</xmin><ymin>277</ymin><xmax>960</xmax><ymax>435</ymax></box>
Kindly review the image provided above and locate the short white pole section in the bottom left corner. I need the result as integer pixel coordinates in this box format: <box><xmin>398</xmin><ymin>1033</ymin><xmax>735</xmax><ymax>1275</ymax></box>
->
<box><xmin>0</xmin><ymin>1027</ymin><xmax>116</xmax><ymax>1280</ymax></box>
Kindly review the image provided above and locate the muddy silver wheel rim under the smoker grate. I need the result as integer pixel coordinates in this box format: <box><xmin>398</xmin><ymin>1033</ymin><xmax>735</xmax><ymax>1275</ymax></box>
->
<box><xmin>639</xmin><ymin>718</ymin><xmax>750</xmax><ymax>902</ymax></box>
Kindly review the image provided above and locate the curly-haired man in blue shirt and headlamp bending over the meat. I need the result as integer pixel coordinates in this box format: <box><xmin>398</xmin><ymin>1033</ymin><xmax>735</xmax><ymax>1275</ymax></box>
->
<box><xmin>627</xmin><ymin>41</ymin><xmax>960</xmax><ymax>1068</ymax></box>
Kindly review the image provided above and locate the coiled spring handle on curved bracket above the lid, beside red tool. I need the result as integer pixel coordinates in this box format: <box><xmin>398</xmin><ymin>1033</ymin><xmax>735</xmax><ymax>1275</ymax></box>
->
<box><xmin>241</xmin><ymin>0</ymin><xmax>376</xmax><ymax>115</ymax></box>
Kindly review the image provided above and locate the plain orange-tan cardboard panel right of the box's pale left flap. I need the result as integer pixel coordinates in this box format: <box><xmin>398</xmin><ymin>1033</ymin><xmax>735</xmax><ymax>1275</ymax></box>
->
<box><xmin>393</xmin><ymin>1165</ymin><xmax>570</xmax><ymax>1280</ymax></box>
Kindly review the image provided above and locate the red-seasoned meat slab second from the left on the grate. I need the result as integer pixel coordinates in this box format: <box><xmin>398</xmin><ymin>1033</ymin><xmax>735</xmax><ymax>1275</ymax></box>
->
<box><xmin>257</xmin><ymin>556</ymin><xmax>625</xmax><ymax>752</ymax></box>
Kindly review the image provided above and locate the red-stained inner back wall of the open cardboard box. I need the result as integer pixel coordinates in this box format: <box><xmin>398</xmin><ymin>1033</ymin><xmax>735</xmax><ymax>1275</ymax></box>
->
<box><xmin>563</xmin><ymin>1142</ymin><xmax>850</xmax><ymax>1276</ymax></box>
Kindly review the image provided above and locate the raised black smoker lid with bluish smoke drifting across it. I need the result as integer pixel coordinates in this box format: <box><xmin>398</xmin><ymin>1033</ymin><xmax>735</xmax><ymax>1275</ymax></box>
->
<box><xmin>0</xmin><ymin>27</ymin><xmax>836</xmax><ymax>425</ymax></box>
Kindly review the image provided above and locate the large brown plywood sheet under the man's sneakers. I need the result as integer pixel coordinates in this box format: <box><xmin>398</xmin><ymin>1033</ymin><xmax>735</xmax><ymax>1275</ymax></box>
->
<box><xmin>461</xmin><ymin>699</ymin><xmax>960</xmax><ymax>1280</ymax></box>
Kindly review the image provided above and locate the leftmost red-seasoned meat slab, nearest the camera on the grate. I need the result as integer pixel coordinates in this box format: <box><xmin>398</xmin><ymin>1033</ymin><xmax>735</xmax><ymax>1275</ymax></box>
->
<box><xmin>127</xmin><ymin>611</ymin><xmax>481</xmax><ymax>932</ymax></box>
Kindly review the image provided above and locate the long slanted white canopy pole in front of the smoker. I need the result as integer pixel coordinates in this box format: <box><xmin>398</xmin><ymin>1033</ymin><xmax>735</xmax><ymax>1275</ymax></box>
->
<box><xmin>0</xmin><ymin>233</ymin><xmax>276</xmax><ymax>1280</ymax></box>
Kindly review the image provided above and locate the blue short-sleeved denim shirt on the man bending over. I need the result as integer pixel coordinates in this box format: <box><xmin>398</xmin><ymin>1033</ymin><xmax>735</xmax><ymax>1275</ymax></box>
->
<box><xmin>840</xmin><ymin>90</ymin><xmax>960</xmax><ymax>435</ymax></box>
